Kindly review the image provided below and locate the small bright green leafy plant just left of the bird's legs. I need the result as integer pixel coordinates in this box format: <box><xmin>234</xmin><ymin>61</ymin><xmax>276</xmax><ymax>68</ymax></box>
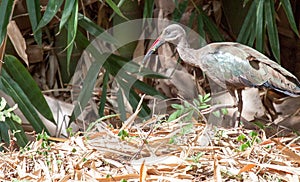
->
<box><xmin>168</xmin><ymin>93</ymin><xmax>211</xmax><ymax>121</ymax></box>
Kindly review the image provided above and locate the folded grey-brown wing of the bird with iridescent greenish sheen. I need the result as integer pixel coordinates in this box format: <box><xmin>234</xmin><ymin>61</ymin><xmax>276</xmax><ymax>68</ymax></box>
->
<box><xmin>198</xmin><ymin>42</ymin><xmax>300</xmax><ymax>95</ymax></box>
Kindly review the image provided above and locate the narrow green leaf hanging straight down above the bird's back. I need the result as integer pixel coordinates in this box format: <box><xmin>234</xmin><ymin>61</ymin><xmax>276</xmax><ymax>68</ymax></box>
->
<box><xmin>255</xmin><ymin>0</ymin><xmax>264</xmax><ymax>53</ymax></box>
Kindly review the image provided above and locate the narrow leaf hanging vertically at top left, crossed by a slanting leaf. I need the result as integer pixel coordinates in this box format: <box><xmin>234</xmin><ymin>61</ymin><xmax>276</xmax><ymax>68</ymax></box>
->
<box><xmin>26</xmin><ymin>0</ymin><xmax>42</xmax><ymax>45</ymax></box>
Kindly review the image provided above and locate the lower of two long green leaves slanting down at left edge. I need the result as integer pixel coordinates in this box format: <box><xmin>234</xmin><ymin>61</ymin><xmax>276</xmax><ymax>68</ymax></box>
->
<box><xmin>0</xmin><ymin>69</ymin><xmax>49</xmax><ymax>133</ymax></box>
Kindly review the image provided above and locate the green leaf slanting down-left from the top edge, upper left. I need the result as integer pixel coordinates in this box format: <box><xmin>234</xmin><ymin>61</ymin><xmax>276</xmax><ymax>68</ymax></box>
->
<box><xmin>34</xmin><ymin>0</ymin><xmax>63</xmax><ymax>34</ymax></box>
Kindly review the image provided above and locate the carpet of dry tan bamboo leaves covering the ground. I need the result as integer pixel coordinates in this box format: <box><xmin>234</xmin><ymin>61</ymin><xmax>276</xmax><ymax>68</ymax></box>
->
<box><xmin>0</xmin><ymin>115</ymin><xmax>300</xmax><ymax>181</ymax></box>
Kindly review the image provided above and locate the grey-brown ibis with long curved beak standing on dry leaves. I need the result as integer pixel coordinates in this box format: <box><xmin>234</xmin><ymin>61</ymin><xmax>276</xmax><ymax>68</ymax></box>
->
<box><xmin>143</xmin><ymin>24</ymin><xmax>300</xmax><ymax>123</ymax></box>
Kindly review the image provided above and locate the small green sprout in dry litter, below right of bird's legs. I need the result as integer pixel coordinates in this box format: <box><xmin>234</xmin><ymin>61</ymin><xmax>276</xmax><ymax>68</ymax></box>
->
<box><xmin>237</xmin><ymin>131</ymin><xmax>261</xmax><ymax>151</ymax></box>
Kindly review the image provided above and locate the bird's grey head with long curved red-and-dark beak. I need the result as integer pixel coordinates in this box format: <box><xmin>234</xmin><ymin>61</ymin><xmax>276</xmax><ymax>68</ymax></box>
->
<box><xmin>143</xmin><ymin>24</ymin><xmax>185</xmax><ymax>63</ymax></box>
